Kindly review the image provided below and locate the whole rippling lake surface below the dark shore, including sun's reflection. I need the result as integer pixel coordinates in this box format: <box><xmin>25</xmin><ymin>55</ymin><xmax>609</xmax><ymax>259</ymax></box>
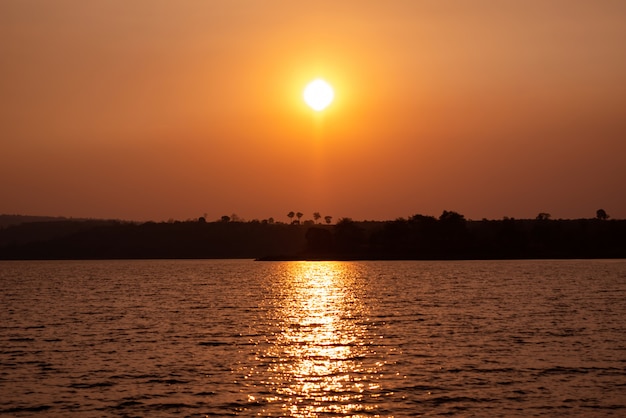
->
<box><xmin>0</xmin><ymin>260</ymin><xmax>626</xmax><ymax>417</ymax></box>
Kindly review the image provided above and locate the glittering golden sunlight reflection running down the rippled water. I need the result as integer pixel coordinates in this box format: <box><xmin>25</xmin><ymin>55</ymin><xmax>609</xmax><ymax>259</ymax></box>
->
<box><xmin>249</xmin><ymin>262</ymin><xmax>390</xmax><ymax>417</ymax></box>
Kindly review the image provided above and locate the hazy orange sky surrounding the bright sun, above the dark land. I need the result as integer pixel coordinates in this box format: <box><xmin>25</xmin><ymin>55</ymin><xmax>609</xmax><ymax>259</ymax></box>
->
<box><xmin>0</xmin><ymin>0</ymin><xmax>626</xmax><ymax>221</ymax></box>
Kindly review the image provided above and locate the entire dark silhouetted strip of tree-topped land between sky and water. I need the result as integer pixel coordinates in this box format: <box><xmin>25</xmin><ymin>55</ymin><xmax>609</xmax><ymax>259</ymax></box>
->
<box><xmin>0</xmin><ymin>211</ymin><xmax>626</xmax><ymax>260</ymax></box>
